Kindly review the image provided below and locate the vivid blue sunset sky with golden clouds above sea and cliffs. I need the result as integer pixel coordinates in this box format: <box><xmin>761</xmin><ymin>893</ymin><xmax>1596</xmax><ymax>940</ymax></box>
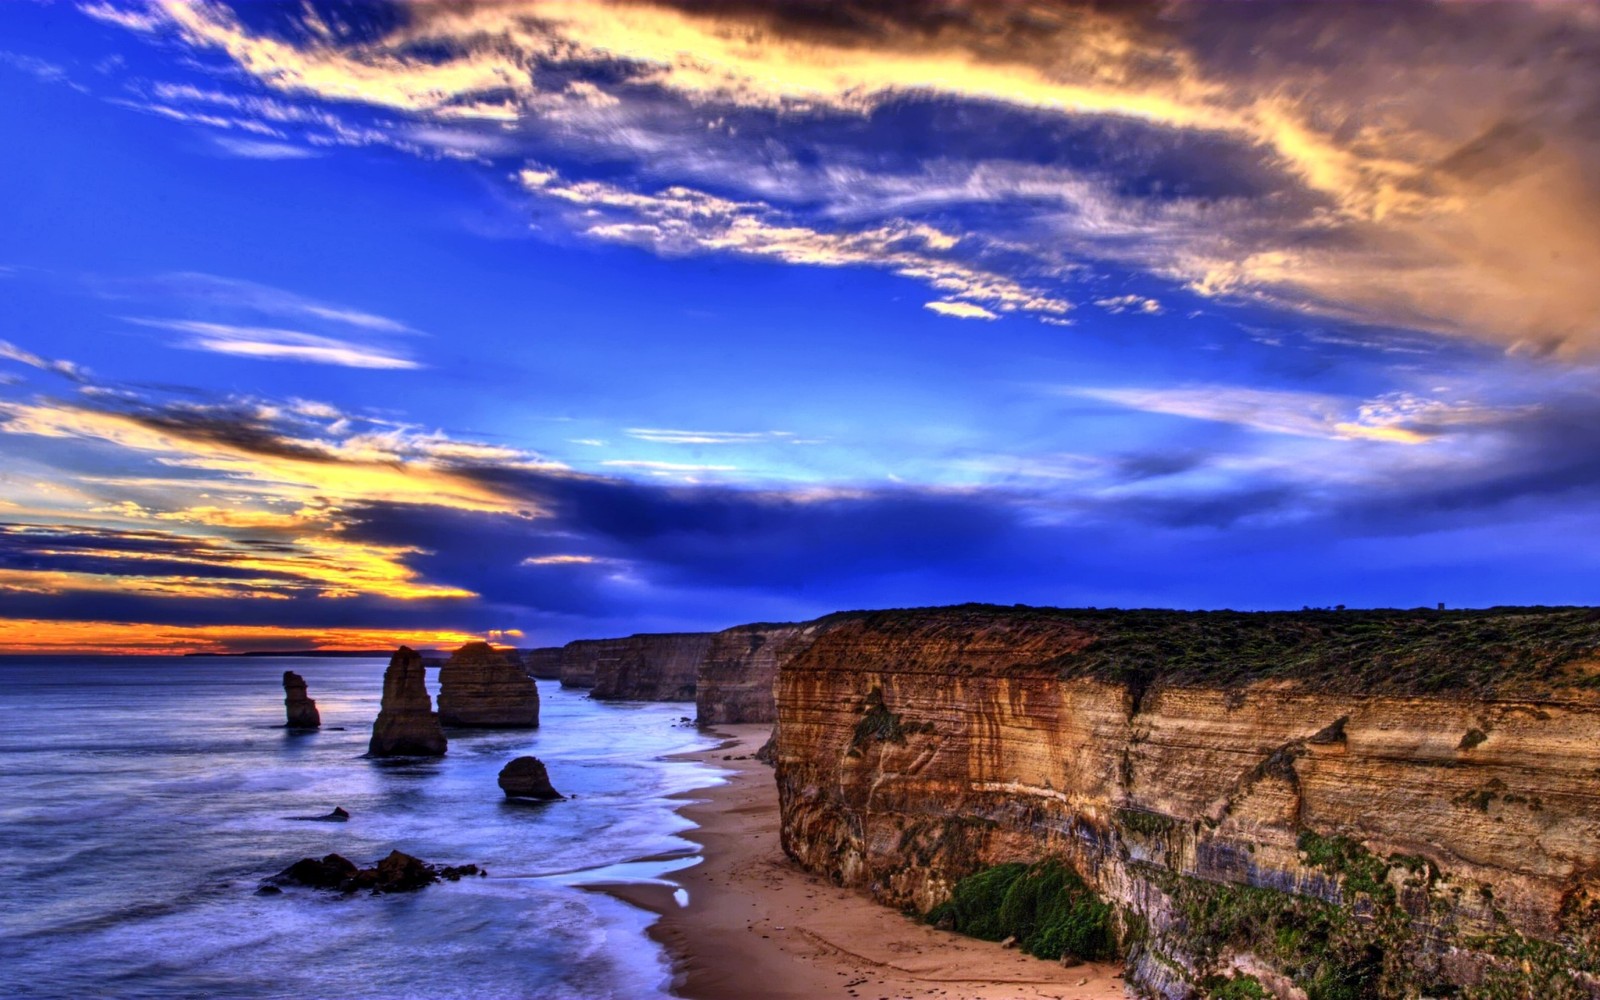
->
<box><xmin>0</xmin><ymin>0</ymin><xmax>1600</xmax><ymax>653</ymax></box>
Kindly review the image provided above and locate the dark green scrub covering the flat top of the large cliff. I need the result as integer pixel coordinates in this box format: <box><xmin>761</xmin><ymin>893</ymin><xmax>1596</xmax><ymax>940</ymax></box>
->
<box><xmin>861</xmin><ymin>605</ymin><xmax>1600</xmax><ymax>696</ymax></box>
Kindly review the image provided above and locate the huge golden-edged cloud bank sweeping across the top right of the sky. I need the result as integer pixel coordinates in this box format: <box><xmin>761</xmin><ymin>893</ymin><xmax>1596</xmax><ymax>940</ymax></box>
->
<box><xmin>90</xmin><ymin>0</ymin><xmax>1600</xmax><ymax>357</ymax></box>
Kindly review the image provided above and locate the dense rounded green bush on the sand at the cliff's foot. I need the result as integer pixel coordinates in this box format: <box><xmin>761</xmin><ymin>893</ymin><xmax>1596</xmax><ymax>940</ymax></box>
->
<box><xmin>928</xmin><ymin>861</ymin><xmax>1115</xmax><ymax>960</ymax></box>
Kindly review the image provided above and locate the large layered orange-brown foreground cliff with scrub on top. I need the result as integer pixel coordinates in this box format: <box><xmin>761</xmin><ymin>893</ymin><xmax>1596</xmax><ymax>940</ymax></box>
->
<box><xmin>776</xmin><ymin>606</ymin><xmax>1600</xmax><ymax>1000</ymax></box>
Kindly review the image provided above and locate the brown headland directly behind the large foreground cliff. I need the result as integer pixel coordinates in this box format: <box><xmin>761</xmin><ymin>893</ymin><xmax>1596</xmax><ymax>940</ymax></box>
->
<box><xmin>694</xmin><ymin>614</ymin><xmax>850</xmax><ymax>726</ymax></box>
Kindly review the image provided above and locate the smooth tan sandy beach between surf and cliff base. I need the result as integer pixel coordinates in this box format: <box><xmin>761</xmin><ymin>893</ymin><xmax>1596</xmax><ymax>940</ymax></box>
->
<box><xmin>606</xmin><ymin>725</ymin><xmax>1125</xmax><ymax>1000</ymax></box>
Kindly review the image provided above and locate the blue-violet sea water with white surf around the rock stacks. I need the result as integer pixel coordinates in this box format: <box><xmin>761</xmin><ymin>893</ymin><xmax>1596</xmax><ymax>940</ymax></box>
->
<box><xmin>0</xmin><ymin>658</ymin><xmax>720</xmax><ymax>1000</ymax></box>
